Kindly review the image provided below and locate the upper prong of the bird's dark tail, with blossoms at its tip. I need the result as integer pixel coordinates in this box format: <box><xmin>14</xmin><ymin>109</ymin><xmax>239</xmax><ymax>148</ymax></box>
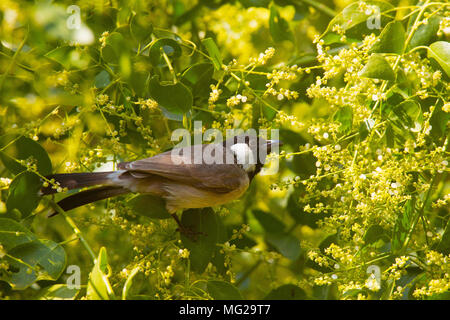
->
<box><xmin>41</xmin><ymin>171</ymin><xmax>117</xmax><ymax>195</ymax></box>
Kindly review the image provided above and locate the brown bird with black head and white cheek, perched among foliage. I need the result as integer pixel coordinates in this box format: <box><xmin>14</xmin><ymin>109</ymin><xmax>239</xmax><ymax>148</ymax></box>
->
<box><xmin>40</xmin><ymin>134</ymin><xmax>282</xmax><ymax>233</ymax></box>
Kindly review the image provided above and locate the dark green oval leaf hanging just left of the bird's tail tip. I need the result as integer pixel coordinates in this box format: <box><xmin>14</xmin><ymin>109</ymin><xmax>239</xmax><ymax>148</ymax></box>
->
<box><xmin>6</xmin><ymin>171</ymin><xmax>42</xmax><ymax>219</ymax></box>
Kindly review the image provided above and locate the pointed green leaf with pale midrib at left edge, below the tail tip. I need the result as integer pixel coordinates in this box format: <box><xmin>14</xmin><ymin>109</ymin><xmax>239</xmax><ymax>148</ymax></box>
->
<box><xmin>0</xmin><ymin>218</ymin><xmax>37</xmax><ymax>251</ymax></box>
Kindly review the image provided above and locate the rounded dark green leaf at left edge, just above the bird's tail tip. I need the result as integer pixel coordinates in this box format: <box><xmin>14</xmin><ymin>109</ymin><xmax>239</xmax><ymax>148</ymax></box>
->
<box><xmin>0</xmin><ymin>136</ymin><xmax>52</xmax><ymax>176</ymax></box>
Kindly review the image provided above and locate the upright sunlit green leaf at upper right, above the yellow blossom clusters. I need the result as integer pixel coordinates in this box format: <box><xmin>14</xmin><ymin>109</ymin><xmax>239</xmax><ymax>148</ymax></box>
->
<box><xmin>369</xmin><ymin>21</ymin><xmax>406</xmax><ymax>54</ymax></box>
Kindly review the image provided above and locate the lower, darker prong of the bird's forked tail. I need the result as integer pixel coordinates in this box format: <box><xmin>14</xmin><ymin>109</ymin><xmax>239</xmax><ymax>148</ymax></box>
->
<box><xmin>49</xmin><ymin>186</ymin><xmax>130</xmax><ymax>217</ymax></box>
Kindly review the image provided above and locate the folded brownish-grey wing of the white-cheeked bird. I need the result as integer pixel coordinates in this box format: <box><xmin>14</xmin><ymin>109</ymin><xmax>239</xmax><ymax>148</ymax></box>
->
<box><xmin>119</xmin><ymin>147</ymin><xmax>243</xmax><ymax>193</ymax></box>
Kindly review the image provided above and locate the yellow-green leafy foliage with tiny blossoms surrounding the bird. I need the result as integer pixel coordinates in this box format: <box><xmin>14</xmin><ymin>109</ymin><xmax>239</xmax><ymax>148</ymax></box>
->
<box><xmin>0</xmin><ymin>0</ymin><xmax>450</xmax><ymax>299</ymax></box>
